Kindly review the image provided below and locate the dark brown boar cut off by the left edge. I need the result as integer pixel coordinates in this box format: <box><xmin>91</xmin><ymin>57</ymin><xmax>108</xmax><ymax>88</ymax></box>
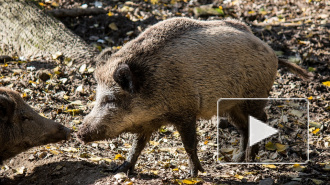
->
<box><xmin>0</xmin><ymin>87</ymin><xmax>71</xmax><ymax>164</ymax></box>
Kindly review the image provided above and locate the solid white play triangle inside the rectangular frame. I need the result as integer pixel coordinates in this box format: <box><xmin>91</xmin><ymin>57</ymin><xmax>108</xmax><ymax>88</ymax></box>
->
<box><xmin>249</xmin><ymin>116</ymin><xmax>278</xmax><ymax>146</ymax></box>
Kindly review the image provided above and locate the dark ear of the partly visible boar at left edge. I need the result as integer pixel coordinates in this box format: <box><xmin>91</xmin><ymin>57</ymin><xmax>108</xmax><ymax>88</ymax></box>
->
<box><xmin>0</xmin><ymin>94</ymin><xmax>15</xmax><ymax>124</ymax></box>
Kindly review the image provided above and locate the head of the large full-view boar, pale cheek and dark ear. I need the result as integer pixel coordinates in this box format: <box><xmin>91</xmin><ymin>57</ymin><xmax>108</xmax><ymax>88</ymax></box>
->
<box><xmin>78</xmin><ymin>63</ymin><xmax>153</xmax><ymax>142</ymax></box>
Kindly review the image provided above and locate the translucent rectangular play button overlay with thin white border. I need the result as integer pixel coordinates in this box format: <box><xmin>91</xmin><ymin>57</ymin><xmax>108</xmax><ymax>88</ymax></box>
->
<box><xmin>218</xmin><ymin>98</ymin><xmax>308</xmax><ymax>164</ymax></box>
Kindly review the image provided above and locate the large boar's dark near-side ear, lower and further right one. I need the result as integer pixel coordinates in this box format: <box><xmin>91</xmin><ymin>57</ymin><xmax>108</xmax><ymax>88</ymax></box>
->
<box><xmin>113</xmin><ymin>64</ymin><xmax>137</xmax><ymax>93</ymax></box>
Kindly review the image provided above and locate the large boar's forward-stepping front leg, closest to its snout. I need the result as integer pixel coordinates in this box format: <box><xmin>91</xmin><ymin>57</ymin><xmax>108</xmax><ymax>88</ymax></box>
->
<box><xmin>116</xmin><ymin>133</ymin><xmax>152</xmax><ymax>174</ymax></box>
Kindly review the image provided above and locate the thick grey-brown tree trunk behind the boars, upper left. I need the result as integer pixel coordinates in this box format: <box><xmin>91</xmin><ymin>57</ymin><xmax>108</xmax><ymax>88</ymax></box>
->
<box><xmin>0</xmin><ymin>0</ymin><xmax>97</xmax><ymax>63</ymax></box>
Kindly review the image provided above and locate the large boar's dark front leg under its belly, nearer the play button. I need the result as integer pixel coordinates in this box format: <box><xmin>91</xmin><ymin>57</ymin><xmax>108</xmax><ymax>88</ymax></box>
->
<box><xmin>176</xmin><ymin>118</ymin><xmax>204</xmax><ymax>177</ymax></box>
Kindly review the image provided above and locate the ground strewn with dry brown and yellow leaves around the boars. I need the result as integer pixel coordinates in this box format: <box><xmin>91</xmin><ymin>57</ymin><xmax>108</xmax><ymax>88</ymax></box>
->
<box><xmin>0</xmin><ymin>0</ymin><xmax>330</xmax><ymax>185</ymax></box>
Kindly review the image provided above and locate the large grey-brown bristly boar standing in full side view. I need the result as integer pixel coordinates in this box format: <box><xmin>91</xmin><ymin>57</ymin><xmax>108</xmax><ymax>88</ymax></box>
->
<box><xmin>78</xmin><ymin>18</ymin><xmax>308</xmax><ymax>176</ymax></box>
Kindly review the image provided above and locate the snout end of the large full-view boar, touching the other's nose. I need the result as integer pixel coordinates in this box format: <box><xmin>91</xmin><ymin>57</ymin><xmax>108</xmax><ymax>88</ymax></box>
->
<box><xmin>77</xmin><ymin>126</ymin><xmax>109</xmax><ymax>143</ymax></box>
